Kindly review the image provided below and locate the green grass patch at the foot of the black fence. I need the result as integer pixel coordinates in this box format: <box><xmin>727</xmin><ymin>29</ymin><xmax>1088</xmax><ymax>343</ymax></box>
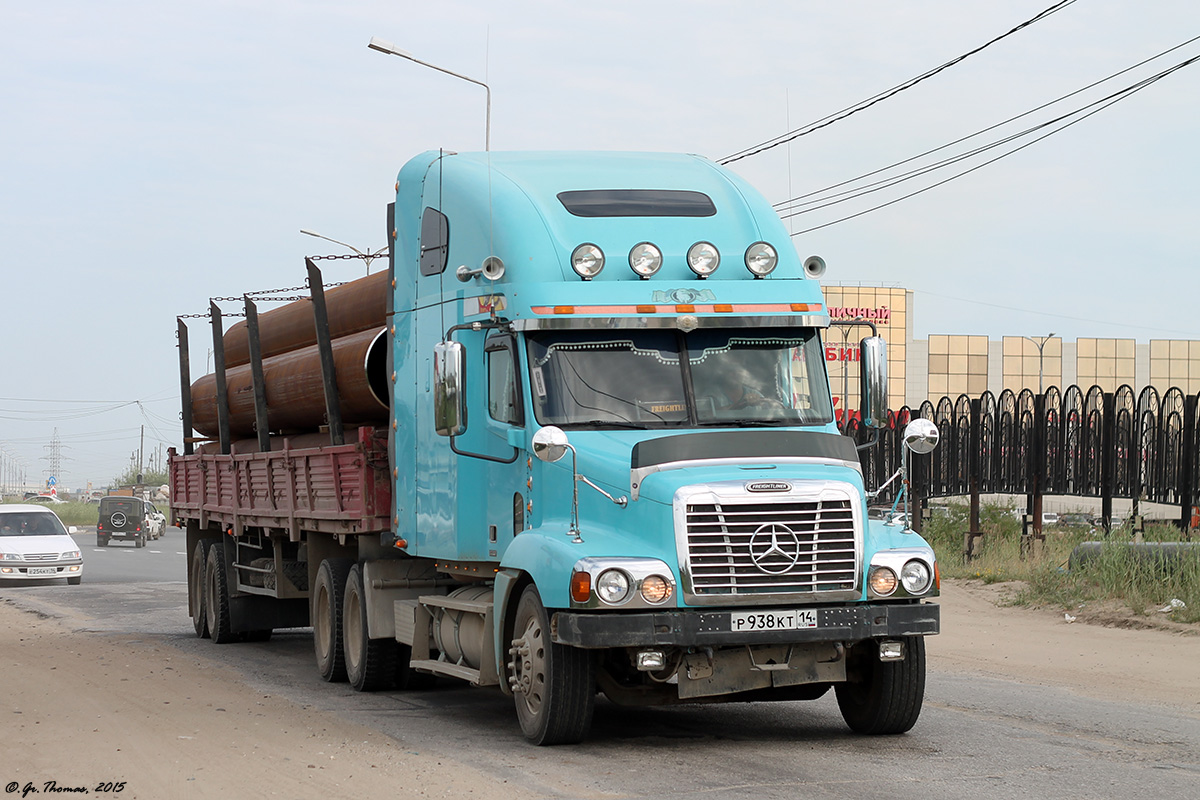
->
<box><xmin>924</xmin><ymin>506</ymin><xmax>1200</xmax><ymax>624</ymax></box>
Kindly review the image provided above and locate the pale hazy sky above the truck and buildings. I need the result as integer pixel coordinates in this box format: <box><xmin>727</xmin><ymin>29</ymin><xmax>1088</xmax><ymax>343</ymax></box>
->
<box><xmin>0</xmin><ymin>0</ymin><xmax>1200</xmax><ymax>488</ymax></box>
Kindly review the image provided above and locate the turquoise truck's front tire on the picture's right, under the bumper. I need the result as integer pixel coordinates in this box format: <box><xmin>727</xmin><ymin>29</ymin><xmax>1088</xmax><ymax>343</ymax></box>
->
<box><xmin>836</xmin><ymin>636</ymin><xmax>925</xmax><ymax>735</ymax></box>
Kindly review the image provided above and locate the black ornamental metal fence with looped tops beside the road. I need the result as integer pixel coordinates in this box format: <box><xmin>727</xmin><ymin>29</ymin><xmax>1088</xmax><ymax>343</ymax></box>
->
<box><xmin>842</xmin><ymin>386</ymin><xmax>1200</xmax><ymax>542</ymax></box>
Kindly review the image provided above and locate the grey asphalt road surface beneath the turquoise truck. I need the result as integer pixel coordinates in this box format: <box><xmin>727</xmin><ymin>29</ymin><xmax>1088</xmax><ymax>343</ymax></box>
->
<box><xmin>0</xmin><ymin>544</ymin><xmax>1200</xmax><ymax>800</ymax></box>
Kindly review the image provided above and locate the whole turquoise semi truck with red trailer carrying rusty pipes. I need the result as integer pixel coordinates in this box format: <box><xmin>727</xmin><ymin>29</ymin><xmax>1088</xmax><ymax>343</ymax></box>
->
<box><xmin>170</xmin><ymin>151</ymin><xmax>940</xmax><ymax>745</ymax></box>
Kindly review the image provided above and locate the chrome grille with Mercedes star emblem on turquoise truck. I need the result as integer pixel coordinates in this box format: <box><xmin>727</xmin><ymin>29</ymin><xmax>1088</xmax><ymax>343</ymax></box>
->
<box><xmin>685</xmin><ymin>494</ymin><xmax>858</xmax><ymax>596</ymax></box>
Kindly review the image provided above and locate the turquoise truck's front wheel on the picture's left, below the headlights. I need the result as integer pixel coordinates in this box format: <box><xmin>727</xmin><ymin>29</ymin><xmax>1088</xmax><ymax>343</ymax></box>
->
<box><xmin>509</xmin><ymin>585</ymin><xmax>596</xmax><ymax>745</ymax></box>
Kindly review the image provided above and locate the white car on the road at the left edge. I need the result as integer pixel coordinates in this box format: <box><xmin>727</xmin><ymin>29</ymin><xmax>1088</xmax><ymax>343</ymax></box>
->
<box><xmin>0</xmin><ymin>504</ymin><xmax>83</xmax><ymax>584</ymax></box>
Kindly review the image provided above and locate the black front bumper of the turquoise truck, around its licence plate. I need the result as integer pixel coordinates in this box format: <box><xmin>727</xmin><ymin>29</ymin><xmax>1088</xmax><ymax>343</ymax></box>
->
<box><xmin>551</xmin><ymin>602</ymin><xmax>941</xmax><ymax>648</ymax></box>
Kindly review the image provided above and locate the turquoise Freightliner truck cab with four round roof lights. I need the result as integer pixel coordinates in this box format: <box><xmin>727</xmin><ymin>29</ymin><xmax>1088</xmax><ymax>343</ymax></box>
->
<box><xmin>389</xmin><ymin>152</ymin><xmax>938</xmax><ymax>744</ymax></box>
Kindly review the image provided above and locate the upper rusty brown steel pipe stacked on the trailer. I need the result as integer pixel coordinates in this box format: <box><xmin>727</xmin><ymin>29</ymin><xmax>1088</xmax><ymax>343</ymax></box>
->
<box><xmin>222</xmin><ymin>272</ymin><xmax>389</xmax><ymax>367</ymax></box>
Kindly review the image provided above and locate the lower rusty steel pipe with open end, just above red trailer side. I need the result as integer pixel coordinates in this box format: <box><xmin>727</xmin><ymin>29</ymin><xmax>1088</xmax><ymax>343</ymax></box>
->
<box><xmin>192</xmin><ymin>329</ymin><xmax>388</xmax><ymax>439</ymax></box>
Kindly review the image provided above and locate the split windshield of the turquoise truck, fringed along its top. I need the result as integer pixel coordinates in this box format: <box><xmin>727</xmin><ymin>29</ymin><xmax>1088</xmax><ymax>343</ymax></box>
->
<box><xmin>528</xmin><ymin>327</ymin><xmax>833</xmax><ymax>428</ymax></box>
